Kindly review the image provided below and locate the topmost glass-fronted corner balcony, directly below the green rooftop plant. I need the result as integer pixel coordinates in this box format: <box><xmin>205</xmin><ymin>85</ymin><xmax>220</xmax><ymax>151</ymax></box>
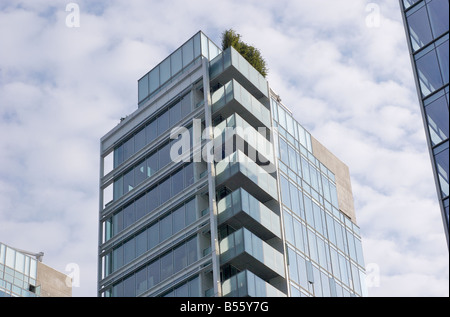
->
<box><xmin>209</xmin><ymin>47</ymin><xmax>269</xmax><ymax>101</ymax></box>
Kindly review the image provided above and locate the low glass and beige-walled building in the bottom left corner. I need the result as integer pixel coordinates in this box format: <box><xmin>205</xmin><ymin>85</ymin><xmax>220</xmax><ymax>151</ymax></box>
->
<box><xmin>0</xmin><ymin>243</ymin><xmax>72</xmax><ymax>297</ymax></box>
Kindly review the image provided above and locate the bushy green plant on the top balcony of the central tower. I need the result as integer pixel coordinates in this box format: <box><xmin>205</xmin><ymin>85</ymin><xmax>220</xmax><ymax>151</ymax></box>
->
<box><xmin>222</xmin><ymin>29</ymin><xmax>268</xmax><ymax>77</ymax></box>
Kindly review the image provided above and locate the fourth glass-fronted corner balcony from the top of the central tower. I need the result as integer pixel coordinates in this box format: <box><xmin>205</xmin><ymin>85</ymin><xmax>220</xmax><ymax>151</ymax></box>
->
<box><xmin>216</xmin><ymin>150</ymin><xmax>278</xmax><ymax>203</ymax></box>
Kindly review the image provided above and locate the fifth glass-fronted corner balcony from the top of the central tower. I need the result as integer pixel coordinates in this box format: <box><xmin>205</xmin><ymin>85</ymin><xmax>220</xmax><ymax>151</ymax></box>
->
<box><xmin>217</xmin><ymin>188</ymin><xmax>281</xmax><ymax>240</ymax></box>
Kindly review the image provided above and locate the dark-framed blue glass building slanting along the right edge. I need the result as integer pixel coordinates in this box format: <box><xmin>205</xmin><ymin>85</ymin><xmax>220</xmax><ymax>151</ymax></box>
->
<box><xmin>400</xmin><ymin>0</ymin><xmax>449</xmax><ymax>246</ymax></box>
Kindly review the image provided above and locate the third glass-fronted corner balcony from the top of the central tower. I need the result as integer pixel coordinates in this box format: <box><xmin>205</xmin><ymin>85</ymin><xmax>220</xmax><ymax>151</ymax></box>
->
<box><xmin>214</xmin><ymin>113</ymin><xmax>274</xmax><ymax>168</ymax></box>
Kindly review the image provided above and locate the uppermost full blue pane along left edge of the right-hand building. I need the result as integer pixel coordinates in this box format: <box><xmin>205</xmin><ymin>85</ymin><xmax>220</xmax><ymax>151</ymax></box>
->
<box><xmin>408</xmin><ymin>6</ymin><xmax>433</xmax><ymax>50</ymax></box>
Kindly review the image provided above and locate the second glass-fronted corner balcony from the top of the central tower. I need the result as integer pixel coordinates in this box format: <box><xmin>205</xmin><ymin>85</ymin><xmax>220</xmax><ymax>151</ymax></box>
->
<box><xmin>211</xmin><ymin>79</ymin><xmax>271</xmax><ymax>129</ymax></box>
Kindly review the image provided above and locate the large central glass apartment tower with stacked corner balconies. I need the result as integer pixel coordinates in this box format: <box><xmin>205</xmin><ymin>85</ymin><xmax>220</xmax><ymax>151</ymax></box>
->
<box><xmin>98</xmin><ymin>32</ymin><xmax>366</xmax><ymax>297</ymax></box>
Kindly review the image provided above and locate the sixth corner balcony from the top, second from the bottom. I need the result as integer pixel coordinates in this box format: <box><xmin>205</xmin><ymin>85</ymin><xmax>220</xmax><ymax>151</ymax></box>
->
<box><xmin>219</xmin><ymin>228</ymin><xmax>284</xmax><ymax>281</ymax></box>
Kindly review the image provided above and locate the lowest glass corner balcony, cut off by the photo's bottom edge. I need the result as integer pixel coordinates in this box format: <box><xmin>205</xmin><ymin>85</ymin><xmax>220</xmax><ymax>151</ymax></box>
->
<box><xmin>222</xmin><ymin>270</ymin><xmax>286</xmax><ymax>297</ymax></box>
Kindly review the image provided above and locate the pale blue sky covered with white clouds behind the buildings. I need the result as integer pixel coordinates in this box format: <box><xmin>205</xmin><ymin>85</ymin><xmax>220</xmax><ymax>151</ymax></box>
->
<box><xmin>0</xmin><ymin>0</ymin><xmax>449</xmax><ymax>296</ymax></box>
